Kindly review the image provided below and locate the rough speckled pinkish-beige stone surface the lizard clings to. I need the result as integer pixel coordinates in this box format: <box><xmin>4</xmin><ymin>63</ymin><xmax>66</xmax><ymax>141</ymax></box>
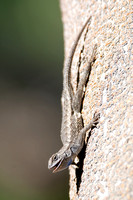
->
<box><xmin>60</xmin><ymin>0</ymin><xmax>133</xmax><ymax>200</ymax></box>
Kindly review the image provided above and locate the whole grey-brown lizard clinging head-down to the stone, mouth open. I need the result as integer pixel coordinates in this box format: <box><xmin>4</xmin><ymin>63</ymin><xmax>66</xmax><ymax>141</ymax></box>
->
<box><xmin>48</xmin><ymin>17</ymin><xmax>100</xmax><ymax>172</ymax></box>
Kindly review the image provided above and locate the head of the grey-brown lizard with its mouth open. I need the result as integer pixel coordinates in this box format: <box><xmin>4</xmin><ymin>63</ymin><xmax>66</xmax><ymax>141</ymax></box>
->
<box><xmin>48</xmin><ymin>148</ymin><xmax>73</xmax><ymax>172</ymax></box>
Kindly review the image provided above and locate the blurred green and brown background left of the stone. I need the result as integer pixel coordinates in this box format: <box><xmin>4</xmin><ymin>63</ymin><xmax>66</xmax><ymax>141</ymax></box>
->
<box><xmin>0</xmin><ymin>0</ymin><xmax>68</xmax><ymax>200</ymax></box>
